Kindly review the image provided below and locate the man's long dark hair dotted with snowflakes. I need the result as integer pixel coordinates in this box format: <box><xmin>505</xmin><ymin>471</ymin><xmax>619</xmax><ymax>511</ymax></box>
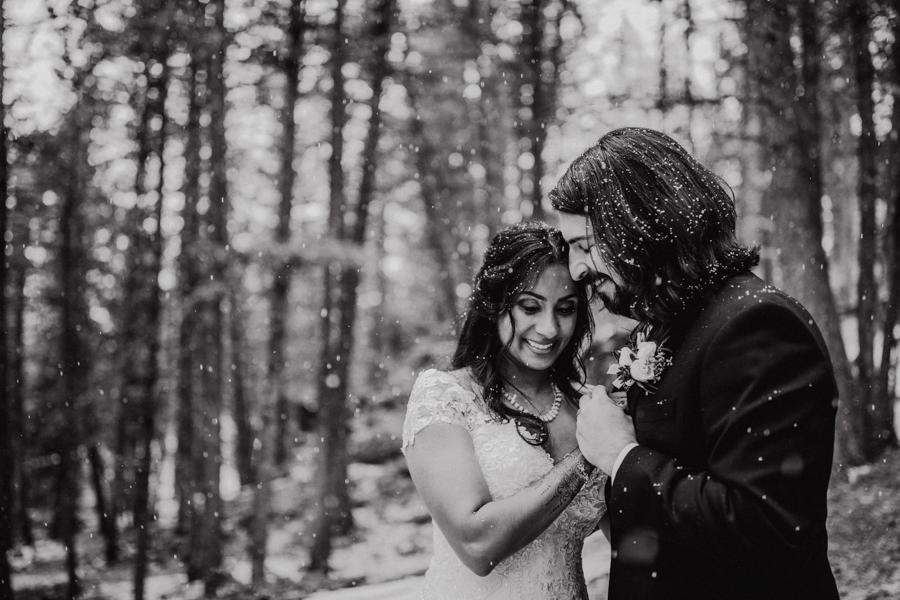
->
<box><xmin>549</xmin><ymin>127</ymin><xmax>759</xmax><ymax>324</ymax></box>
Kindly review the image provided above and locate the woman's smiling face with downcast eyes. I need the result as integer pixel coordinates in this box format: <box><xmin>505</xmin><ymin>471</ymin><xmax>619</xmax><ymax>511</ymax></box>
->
<box><xmin>497</xmin><ymin>264</ymin><xmax>578</xmax><ymax>371</ymax></box>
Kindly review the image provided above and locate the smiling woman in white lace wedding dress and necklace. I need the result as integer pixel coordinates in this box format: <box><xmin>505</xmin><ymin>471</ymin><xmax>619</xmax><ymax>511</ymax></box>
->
<box><xmin>403</xmin><ymin>222</ymin><xmax>606</xmax><ymax>600</ymax></box>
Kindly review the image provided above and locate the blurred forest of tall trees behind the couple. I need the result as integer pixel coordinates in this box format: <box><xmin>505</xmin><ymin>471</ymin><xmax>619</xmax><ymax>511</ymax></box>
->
<box><xmin>0</xmin><ymin>0</ymin><xmax>900</xmax><ymax>600</ymax></box>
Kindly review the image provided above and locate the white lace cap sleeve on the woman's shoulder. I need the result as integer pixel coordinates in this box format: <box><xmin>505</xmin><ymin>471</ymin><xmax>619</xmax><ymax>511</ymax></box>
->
<box><xmin>403</xmin><ymin>369</ymin><xmax>473</xmax><ymax>453</ymax></box>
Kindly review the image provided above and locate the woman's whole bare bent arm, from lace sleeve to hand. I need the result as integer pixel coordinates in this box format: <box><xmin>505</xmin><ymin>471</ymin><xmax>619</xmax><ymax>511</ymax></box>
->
<box><xmin>406</xmin><ymin>423</ymin><xmax>593</xmax><ymax>576</ymax></box>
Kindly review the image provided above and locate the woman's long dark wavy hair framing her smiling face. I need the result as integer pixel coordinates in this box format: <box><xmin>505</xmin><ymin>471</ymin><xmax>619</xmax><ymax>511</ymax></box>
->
<box><xmin>451</xmin><ymin>221</ymin><xmax>593</xmax><ymax>443</ymax></box>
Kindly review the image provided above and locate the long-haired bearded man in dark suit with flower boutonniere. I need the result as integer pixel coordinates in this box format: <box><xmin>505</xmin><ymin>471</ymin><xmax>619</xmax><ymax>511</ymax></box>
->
<box><xmin>550</xmin><ymin>128</ymin><xmax>838</xmax><ymax>600</ymax></box>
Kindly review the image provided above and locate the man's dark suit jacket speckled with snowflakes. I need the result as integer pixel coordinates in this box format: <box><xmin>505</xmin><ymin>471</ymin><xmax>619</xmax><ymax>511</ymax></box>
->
<box><xmin>607</xmin><ymin>273</ymin><xmax>838</xmax><ymax>600</ymax></box>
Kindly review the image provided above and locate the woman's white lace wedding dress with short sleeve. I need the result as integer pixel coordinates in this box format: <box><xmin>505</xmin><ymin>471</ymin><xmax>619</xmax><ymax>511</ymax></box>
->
<box><xmin>403</xmin><ymin>369</ymin><xmax>606</xmax><ymax>600</ymax></box>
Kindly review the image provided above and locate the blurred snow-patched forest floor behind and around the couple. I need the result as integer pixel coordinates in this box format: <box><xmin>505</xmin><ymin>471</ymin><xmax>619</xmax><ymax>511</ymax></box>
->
<box><xmin>10</xmin><ymin>404</ymin><xmax>900</xmax><ymax>600</ymax></box>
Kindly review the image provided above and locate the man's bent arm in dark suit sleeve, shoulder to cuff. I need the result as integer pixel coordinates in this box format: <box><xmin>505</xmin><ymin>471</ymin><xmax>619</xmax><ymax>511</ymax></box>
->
<box><xmin>610</xmin><ymin>300</ymin><xmax>837</xmax><ymax>561</ymax></box>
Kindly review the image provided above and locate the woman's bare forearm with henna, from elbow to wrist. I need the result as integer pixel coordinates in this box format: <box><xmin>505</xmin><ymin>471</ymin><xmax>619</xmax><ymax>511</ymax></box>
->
<box><xmin>463</xmin><ymin>449</ymin><xmax>593</xmax><ymax>575</ymax></box>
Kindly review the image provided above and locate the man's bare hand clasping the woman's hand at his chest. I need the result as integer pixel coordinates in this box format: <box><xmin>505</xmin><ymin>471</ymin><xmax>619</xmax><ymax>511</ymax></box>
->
<box><xmin>576</xmin><ymin>385</ymin><xmax>637</xmax><ymax>475</ymax></box>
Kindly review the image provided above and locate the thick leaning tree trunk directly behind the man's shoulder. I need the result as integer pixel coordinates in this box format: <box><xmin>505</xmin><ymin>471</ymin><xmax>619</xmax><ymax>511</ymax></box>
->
<box><xmin>744</xmin><ymin>0</ymin><xmax>862</xmax><ymax>464</ymax></box>
